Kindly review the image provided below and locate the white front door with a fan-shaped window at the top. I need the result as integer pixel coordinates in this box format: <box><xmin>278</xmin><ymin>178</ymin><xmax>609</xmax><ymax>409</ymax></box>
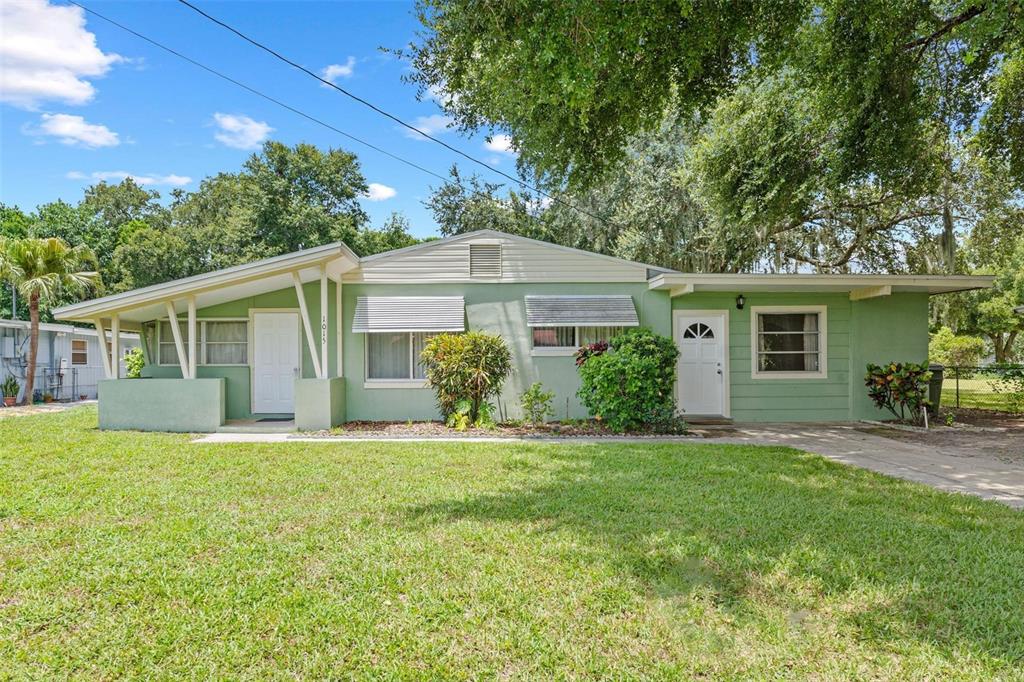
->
<box><xmin>675</xmin><ymin>312</ymin><xmax>728</xmax><ymax>416</ymax></box>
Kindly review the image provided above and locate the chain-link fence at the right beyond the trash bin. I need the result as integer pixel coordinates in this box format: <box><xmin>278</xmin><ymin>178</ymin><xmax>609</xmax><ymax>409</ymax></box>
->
<box><xmin>942</xmin><ymin>365</ymin><xmax>1024</xmax><ymax>414</ymax></box>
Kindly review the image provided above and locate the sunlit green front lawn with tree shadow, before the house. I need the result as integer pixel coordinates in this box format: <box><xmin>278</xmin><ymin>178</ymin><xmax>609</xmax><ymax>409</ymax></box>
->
<box><xmin>0</xmin><ymin>410</ymin><xmax>1024</xmax><ymax>679</ymax></box>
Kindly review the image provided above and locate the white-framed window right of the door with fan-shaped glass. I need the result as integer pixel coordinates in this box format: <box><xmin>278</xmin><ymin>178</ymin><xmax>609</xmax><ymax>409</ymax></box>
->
<box><xmin>751</xmin><ymin>306</ymin><xmax>826</xmax><ymax>378</ymax></box>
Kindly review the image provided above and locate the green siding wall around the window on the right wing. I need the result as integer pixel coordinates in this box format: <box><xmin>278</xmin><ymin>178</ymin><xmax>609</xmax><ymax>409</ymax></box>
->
<box><xmin>672</xmin><ymin>292</ymin><xmax>928</xmax><ymax>422</ymax></box>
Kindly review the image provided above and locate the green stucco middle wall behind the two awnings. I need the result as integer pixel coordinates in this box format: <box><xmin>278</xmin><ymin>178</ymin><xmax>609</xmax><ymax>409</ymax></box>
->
<box><xmin>342</xmin><ymin>283</ymin><xmax>672</xmax><ymax>420</ymax></box>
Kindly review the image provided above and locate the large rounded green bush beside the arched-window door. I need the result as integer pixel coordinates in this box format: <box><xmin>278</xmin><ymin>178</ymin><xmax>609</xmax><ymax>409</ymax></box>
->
<box><xmin>577</xmin><ymin>328</ymin><xmax>679</xmax><ymax>432</ymax></box>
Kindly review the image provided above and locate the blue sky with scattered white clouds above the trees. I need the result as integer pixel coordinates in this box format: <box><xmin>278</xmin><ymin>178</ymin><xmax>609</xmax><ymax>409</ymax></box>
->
<box><xmin>0</xmin><ymin>0</ymin><xmax>515</xmax><ymax>236</ymax></box>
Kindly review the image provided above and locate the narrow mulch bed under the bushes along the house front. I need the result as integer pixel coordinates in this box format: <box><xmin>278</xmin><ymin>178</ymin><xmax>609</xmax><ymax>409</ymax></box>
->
<box><xmin>301</xmin><ymin>421</ymin><xmax>698</xmax><ymax>438</ymax></box>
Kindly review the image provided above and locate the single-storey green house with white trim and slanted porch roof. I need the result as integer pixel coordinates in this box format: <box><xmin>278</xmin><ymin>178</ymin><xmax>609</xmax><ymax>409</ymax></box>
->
<box><xmin>54</xmin><ymin>230</ymin><xmax>991</xmax><ymax>431</ymax></box>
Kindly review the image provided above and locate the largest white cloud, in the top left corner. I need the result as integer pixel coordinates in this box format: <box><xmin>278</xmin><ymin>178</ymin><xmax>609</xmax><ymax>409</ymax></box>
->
<box><xmin>0</xmin><ymin>0</ymin><xmax>124</xmax><ymax>109</ymax></box>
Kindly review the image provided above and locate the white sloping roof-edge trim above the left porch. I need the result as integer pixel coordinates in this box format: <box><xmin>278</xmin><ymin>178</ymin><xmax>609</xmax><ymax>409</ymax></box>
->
<box><xmin>53</xmin><ymin>242</ymin><xmax>359</xmax><ymax>319</ymax></box>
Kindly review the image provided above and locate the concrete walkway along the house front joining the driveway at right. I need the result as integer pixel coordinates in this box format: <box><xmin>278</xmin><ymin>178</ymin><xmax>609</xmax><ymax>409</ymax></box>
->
<box><xmin>197</xmin><ymin>424</ymin><xmax>1024</xmax><ymax>509</ymax></box>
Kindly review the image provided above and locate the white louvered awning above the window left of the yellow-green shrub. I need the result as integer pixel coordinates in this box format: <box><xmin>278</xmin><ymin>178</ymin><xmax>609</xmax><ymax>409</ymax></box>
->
<box><xmin>352</xmin><ymin>296</ymin><xmax>466</xmax><ymax>334</ymax></box>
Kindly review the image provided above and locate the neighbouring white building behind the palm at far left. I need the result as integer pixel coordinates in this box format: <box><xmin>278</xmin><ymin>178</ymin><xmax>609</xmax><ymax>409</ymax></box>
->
<box><xmin>0</xmin><ymin>319</ymin><xmax>139</xmax><ymax>400</ymax></box>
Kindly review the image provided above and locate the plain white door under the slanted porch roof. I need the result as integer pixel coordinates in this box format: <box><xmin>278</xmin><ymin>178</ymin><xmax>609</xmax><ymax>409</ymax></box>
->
<box><xmin>253</xmin><ymin>312</ymin><xmax>302</xmax><ymax>414</ymax></box>
